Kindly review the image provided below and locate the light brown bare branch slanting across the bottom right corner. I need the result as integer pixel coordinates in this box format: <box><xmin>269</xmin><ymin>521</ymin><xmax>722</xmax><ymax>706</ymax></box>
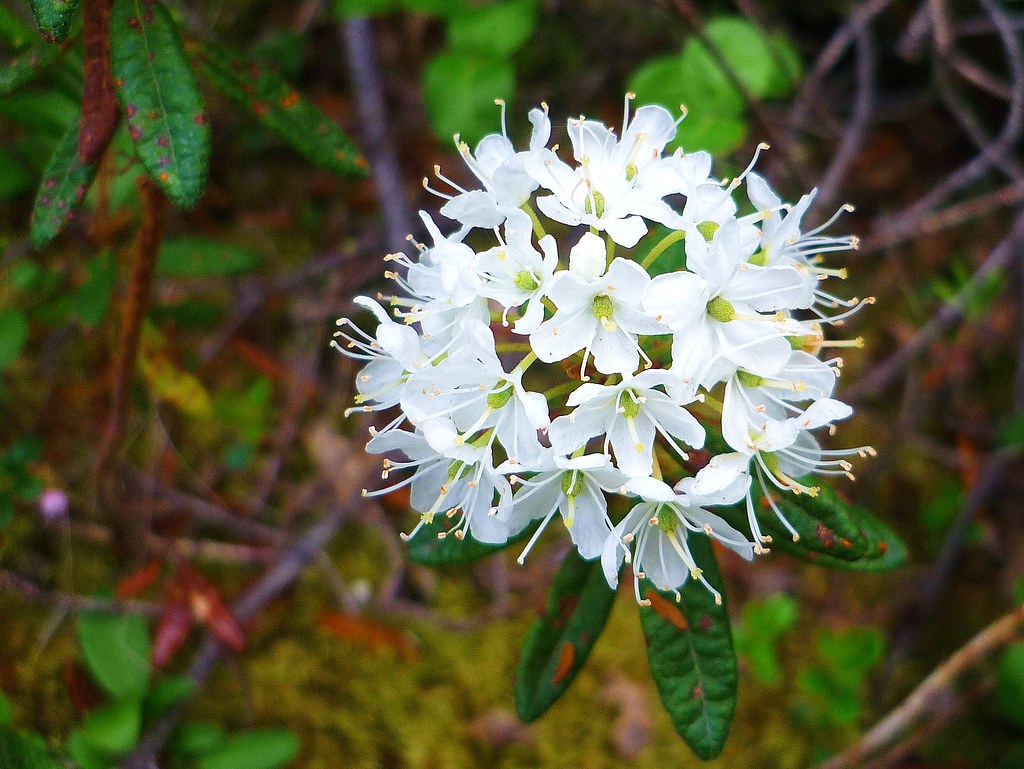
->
<box><xmin>817</xmin><ymin>605</ymin><xmax>1024</xmax><ymax>769</ymax></box>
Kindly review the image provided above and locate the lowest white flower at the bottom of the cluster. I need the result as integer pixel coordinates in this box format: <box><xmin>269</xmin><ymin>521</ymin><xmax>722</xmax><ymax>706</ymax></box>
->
<box><xmin>601</xmin><ymin>470</ymin><xmax>754</xmax><ymax>603</ymax></box>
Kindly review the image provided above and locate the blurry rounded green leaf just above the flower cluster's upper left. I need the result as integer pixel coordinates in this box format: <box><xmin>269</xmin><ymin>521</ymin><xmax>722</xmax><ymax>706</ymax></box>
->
<box><xmin>423</xmin><ymin>51</ymin><xmax>515</xmax><ymax>144</ymax></box>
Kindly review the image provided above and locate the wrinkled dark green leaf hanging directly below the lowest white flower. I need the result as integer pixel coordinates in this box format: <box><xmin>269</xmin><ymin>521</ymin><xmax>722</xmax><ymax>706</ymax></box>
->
<box><xmin>640</xmin><ymin>536</ymin><xmax>737</xmax><ymax>761</ymax></box>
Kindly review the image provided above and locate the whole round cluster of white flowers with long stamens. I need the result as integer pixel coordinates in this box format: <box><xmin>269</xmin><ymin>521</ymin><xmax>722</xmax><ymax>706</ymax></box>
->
<box><xmin>335</xmin><ymin>96</ymin><xmax>870</xmax><ymax>600</ymax></box>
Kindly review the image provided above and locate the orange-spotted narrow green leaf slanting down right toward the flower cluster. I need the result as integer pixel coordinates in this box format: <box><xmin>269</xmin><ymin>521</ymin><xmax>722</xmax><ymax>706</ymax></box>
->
<box><xmin>198</xmin><ymin>44</ymin><xmax>367</xmax><ymax>176</ymax></box>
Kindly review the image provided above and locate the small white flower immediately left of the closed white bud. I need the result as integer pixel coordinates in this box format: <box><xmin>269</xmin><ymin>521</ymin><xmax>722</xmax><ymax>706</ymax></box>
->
<box><xmin>477</xmin><ymin>210</ymin><xmax>558</xmax><ymax>334</ymax></box>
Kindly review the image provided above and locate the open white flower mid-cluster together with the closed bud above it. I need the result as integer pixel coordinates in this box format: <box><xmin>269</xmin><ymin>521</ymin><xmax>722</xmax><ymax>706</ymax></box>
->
<box><xmin>529</xmin><ymin>246</ymin><xmax>667</xmax><ymax>377</ymax></box>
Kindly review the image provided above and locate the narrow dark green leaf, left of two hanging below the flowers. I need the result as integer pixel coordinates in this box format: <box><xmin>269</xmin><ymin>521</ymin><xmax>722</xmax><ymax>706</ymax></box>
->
<box><xmin>515</xmin><ymin>550</ymin><xmax>615</xmax><ymax>722</ymax></box>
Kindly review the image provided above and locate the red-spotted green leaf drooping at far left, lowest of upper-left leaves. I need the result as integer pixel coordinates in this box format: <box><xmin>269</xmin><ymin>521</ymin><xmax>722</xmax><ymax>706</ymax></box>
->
<box><xmin>29</xmin><ymin>111</ymin><xmax>97</xmax><ymax>249</ymax></box>
